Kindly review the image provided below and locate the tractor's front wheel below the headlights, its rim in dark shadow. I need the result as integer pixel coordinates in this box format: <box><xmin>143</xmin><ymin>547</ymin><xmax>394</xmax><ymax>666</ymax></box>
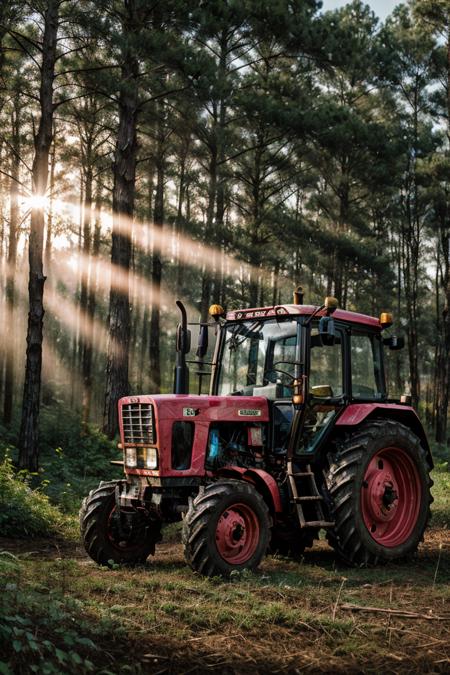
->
<box><xmin>80</xmin><ymin>481</ymin><xmax>161</xmax><ymax>567</ymax></box>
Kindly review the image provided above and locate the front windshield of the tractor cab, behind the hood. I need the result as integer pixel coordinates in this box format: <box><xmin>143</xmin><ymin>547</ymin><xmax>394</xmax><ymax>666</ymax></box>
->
<box><xmin>217</xmin><ymin>319</ymin><xmax>299</xmax><ymax>397</ymax></box>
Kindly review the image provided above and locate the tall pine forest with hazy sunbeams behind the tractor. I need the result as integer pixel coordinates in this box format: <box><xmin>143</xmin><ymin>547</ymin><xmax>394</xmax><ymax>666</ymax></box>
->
<box><xmin>0</xmin><ymin>0</ymin><xmax>450</xmax><ymax>469</ymax></box>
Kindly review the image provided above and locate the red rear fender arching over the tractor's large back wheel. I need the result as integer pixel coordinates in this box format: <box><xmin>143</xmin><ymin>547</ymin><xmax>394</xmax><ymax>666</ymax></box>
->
<box><xmin>336</xmin><ymin>403</ymin><xmax>434</xmax><ymax>468</ymax></box>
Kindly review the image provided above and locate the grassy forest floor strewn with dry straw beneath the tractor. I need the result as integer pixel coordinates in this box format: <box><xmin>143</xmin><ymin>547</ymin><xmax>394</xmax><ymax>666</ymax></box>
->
<box><xmin>0</xmin><ymin>474</ymin><xmax>450</xmax><ymax>675</ymax></box>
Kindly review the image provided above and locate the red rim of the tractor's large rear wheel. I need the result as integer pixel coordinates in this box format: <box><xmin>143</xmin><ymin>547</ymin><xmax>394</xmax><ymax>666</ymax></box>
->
<box><xmin>361</xmin><ymin>447</ymin><xmax>422</xmax><ymax>548</ymax></box>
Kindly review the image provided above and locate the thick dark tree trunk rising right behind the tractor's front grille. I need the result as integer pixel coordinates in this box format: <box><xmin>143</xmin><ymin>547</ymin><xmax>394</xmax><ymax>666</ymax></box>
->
<box><xmin>104</xmin><ymin>46</ymin><xmax>139</xmax><ymax>438</ymax></box>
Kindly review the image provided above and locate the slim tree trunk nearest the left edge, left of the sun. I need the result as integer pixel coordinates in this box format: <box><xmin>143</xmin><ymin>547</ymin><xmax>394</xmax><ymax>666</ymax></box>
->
<box><xmin>3</xmin><ymin>98</ymin><xmax>20</xmax><ymax>426</ymax></box>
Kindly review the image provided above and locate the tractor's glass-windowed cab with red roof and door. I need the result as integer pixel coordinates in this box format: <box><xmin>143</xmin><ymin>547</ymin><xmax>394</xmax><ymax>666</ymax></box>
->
<box><xmin>211</xmin><ymin>301</ymin><xmax>389</xmax><ymax>454</ymax></box>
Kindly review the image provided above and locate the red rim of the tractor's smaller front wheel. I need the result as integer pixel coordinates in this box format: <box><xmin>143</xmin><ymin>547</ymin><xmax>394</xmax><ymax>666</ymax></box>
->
<box><xmin>216</xmin><ymin>504</ymin><xmax>259</xmax><ymax>565</ymax></box>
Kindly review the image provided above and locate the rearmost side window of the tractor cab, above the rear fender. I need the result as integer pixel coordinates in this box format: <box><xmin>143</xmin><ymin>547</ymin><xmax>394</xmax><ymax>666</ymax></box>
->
<box><xmin>350</xmin><ymin>333</ymin><xmax>382</xmax><ymax>399</ymax></box>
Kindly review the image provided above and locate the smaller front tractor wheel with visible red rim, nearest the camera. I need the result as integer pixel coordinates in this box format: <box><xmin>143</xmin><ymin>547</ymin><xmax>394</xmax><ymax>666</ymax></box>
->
<box><xmin>183</xmin><ymin>480</ymin><xmax>270</xmax><ymax>576</ymax></box>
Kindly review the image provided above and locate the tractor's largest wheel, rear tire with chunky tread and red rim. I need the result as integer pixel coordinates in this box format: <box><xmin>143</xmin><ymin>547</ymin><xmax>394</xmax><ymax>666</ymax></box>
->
<box><xmin>327</xmin><ymin>420</ymin><xmax>433</xmax><ymax>566</ymax></box>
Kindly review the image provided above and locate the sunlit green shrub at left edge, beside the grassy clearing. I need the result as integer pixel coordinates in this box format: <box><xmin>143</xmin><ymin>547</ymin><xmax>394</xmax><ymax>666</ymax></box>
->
<box><xmin>0</xmin><ymin>456</ymin><xmax>71</xmax><ymax>538</ymax></box>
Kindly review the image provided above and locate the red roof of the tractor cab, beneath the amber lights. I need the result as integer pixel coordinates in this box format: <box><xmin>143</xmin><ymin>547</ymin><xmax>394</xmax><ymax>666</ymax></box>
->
<box><xmin>226</xmin><ymin>305</ymin><xmax>382</xmax><ymax>330</ymax></box>
